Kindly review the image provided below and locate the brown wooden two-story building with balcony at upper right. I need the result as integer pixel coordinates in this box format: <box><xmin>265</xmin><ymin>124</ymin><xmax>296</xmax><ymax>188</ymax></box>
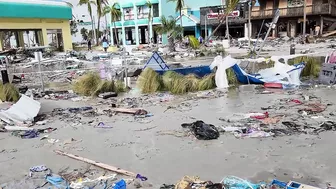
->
<box><xmin>246</xmin><ymin>0</ymin><xmax>336</xmax><ymax>37</ymax></box>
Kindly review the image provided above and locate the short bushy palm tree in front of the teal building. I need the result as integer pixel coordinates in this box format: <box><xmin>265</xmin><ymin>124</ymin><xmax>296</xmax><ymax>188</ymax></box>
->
<box><xmin>155</xmin><ymin>16</ymin><xmax>183</xmax><ymax>51</ymax></box>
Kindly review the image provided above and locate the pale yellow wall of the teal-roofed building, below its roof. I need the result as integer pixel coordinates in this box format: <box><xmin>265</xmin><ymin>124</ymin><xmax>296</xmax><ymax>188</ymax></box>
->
<box><xmin>0</xmin><ymin>18</ymin><xmax>72</xmax><ymax>51</ymax></box>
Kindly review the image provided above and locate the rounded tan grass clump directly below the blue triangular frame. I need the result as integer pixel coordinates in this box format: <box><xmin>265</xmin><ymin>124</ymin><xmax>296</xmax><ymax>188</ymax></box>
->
<box><xmin>137</xmin><ymin>68</ymin><xmax>162</xmax><ymax>93</ymax></box>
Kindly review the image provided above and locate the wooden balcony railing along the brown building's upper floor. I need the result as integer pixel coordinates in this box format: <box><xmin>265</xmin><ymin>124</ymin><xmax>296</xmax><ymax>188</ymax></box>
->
<box><xmin>246</xmin><ymin>4</ymin><xmax>336</xmax><ymax>19</ymax></box>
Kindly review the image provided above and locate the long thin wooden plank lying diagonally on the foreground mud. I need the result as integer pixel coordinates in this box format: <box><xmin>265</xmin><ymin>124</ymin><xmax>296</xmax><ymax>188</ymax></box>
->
<box><xmin>54</xmin><ymin>150</ymin><xmax>137</xmax><ymax>178</ymax></box>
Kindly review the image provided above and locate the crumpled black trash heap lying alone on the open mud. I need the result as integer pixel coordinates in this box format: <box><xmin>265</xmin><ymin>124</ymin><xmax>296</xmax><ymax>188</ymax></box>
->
<box><xmin>181</xmin><ymin>121</ymin><xmax>219</xmax><ymax>140</ymax></box>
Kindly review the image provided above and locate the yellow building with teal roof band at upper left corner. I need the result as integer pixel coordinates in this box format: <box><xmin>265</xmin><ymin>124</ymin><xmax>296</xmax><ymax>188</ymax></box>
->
<box><xmin>0</xmin><ymin>0</ymin><xmax>72</xmax><ymax>51</ymax></box>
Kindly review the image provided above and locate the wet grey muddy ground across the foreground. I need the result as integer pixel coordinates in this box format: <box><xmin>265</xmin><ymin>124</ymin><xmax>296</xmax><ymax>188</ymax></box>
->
<box><xmin>0</xmin><ymin>85</ymin><xmax>336</xmax><ymax>188</ymax></box>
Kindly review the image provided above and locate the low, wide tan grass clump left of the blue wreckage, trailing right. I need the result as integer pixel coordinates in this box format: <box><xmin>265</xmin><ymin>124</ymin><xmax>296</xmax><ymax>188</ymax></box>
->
<box><xmin>73</xmin><ymin>73</ymin><xmax>126</xmax><ymax>96</ymax></box>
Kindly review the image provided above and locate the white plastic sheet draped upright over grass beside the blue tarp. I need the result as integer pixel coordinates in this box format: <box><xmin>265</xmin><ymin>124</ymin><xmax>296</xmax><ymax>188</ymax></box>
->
<box><xmin>210</xmin><ymin>55</ymin><xmax>239</xmax><ymax>89</ymax></box>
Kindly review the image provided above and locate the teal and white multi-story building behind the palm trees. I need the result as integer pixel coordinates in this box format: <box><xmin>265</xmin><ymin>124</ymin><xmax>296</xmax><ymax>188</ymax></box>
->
<box><xmin>110</xmin><ymin>0</ymin><xmax>221</xmax><ymax>45</ymax></box>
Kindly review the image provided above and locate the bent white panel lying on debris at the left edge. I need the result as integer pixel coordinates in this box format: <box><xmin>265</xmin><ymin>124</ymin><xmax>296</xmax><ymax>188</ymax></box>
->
<box><xmin>0</xmin><ymin>94</ymin><xmax>41</xmax><ymax>124</ymax></box>
